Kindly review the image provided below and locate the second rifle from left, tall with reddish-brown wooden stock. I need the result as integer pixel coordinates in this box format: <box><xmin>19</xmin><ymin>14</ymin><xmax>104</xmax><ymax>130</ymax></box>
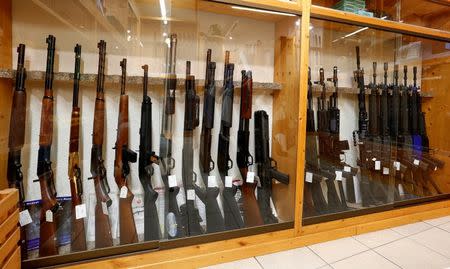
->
<box><xmin>37</xmin><ymin>35</ymin><xmax>60</xmax><ymax>257</ymax></box>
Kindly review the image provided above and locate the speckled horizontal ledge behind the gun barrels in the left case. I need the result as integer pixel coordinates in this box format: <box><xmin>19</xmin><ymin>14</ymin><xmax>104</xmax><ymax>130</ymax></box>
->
<box><xmin>0</xmin><ymin>69</ymin><xmax>281</xmax><ymax>91</ymax></box>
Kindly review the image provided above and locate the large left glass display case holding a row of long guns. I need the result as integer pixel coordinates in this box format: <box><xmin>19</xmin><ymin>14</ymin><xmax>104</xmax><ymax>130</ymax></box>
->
<box><xmin>0</xmin><ymin>0</ymin><xmax>300</xmax><ymax>267</ymax></box>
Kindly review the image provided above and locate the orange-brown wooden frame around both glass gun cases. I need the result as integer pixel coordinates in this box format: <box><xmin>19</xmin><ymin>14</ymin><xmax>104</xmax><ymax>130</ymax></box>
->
<box><xmin>0</xmin><ymin>0</ymin><xmax>450</xmax><ymax>268</ymax></box>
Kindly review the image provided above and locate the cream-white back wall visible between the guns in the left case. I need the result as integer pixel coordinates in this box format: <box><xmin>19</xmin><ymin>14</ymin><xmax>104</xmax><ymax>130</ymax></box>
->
<box><xmin>12</xmin><ymin>0</ymin><xmax>275</xmax><ymax>251</ymax></box>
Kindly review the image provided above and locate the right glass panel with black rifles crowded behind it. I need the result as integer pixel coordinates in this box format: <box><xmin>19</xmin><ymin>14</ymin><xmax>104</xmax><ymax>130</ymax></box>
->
<box><xmin>304</xmin><ymin>19</ymin><xmax>450</xmax><ymax>223</ymax></box>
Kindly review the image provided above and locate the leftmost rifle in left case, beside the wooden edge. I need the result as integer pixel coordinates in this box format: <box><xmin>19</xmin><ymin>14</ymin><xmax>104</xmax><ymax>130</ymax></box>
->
<box><xmin>6</xmin><ymin>44</ymin><xmax>28</xmax><ymax>259</ymax></box>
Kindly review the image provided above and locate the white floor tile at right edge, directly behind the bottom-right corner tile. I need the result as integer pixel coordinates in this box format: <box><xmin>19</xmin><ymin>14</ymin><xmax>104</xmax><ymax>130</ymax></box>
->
<box><xmin>409</xmin><ymin>228</ymin><xmax>450</xmax><ymax>258</ymax></box>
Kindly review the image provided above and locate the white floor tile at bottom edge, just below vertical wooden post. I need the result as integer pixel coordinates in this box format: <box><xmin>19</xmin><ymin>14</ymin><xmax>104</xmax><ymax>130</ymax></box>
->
<box><xmin>255</xmin><ymin>247</ymin><xmax>326</xmax><ymax>269</ymax></box>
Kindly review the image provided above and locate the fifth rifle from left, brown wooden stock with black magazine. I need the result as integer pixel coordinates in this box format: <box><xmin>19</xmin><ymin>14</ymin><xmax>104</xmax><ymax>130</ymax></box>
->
<box><xmin>114</xmin><ymin>59</ymin><xmax>138</xmax><ymax>245</ymax></box>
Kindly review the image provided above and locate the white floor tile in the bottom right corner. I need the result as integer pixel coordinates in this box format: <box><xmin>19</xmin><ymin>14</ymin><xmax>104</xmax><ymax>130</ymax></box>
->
<box><xmin>374</xmin><ymin>238</ymin><xmax>450</xmax><ymax>269</ymax></box>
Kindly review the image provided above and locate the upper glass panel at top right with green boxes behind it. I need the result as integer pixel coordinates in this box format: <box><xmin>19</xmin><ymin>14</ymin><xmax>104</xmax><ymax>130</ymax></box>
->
<box><xmin>312</xmin><ymin>0</ymin><xmax>450</xmax><ymax>31</ymax></box>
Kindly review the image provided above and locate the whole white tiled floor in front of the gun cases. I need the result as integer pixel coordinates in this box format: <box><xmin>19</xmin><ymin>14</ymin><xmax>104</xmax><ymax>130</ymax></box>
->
<box><xmin>200</xmin><ymin>216</ymin><xmax>450</xmax><ymax>269</ymax></box>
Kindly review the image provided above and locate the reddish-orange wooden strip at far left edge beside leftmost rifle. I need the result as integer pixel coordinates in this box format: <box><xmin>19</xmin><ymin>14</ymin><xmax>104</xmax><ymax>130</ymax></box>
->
<box><xmin>0</xmin><ymin>0</ymin><xmax>12</xmax><ymax>190</ymax></box>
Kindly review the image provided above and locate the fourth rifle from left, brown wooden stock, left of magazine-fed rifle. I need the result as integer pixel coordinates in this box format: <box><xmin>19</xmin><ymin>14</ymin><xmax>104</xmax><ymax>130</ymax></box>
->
<box><xmin>89</xmin><ymin>40</ymin><xmax>113</xmax><ymax>248</ymax></box>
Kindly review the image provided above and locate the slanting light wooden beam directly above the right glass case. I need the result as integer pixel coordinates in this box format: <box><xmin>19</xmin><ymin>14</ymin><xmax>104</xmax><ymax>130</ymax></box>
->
<box><xmin>311</xmin><ymin>5</ymin><xmax>450</xmax><ymax>42</ymax></box>
